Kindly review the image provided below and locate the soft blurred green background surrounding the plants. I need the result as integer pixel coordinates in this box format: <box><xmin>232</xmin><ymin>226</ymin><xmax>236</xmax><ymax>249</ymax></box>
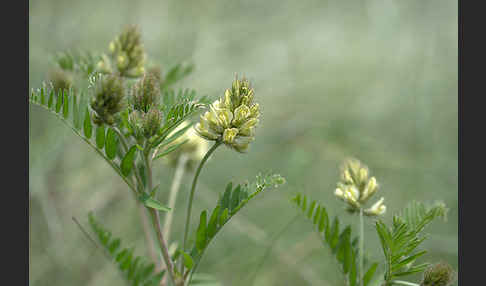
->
<box><xmin>29</xmin><ymin>0</ymin><xmax>458</xmax><ymax>286</ymax></box>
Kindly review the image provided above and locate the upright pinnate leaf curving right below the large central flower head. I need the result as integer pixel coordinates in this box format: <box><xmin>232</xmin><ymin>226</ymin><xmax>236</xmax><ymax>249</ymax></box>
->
<box><xmin>183</xmin><ymin>174</ymin><xmax>285</xmax><ymax>280</ymax></box>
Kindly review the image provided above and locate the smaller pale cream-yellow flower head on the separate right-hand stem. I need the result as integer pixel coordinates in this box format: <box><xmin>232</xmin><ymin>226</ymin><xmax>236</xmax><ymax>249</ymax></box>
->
<box><xmin>334</xmin><ymin>159</ymin><xmax>386</xmax><ymax>216</ymax></box>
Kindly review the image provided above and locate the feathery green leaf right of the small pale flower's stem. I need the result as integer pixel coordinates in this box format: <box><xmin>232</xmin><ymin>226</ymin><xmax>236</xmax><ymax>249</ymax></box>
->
<box><xmin>376</xmin><ymin>202</ymin><xmax>447</xmax><ymax>285</ymax></box>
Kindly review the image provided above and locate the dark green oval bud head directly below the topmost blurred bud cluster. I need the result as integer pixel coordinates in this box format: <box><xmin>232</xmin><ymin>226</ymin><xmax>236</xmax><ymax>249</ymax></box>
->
<box><xmin>90</xmin><ymin>75</ymin><xmax>125</xmax><ymax>125</ymax></box>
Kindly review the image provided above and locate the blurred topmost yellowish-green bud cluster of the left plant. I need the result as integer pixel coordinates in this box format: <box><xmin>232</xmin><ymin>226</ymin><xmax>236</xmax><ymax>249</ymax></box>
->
<box><xmin>97</xmin><ymin>26</ymin><xmax>146</xmax><ymax>77</ymax></box>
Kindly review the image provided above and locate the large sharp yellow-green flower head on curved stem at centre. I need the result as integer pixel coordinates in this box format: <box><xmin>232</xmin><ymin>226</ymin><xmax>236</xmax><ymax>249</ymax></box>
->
<box><xmin>195</xmin><ymin>76</ymin><xmax>260</xmax><ymax>152</ymax></box>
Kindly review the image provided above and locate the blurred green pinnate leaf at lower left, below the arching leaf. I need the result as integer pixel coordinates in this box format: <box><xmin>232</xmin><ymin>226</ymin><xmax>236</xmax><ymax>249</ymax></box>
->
<box><xmin>88</xmin><ymin>213</ymin><xmax>165</xmax><ymax>286</ymax></box>
